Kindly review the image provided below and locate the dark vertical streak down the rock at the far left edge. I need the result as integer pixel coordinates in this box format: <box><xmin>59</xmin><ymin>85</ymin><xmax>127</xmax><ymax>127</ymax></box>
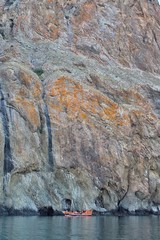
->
<box><xmin>0</xmin><ymin>85</ymin><xmax>14</xmax><ymax>176</ymax></box>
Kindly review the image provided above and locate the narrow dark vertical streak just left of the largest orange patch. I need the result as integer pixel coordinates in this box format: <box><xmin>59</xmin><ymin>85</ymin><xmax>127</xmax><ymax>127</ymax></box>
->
<box><xmin>42</xmin><ymin>85</ymin><xmax>55</xmax><ymax>171</ymax></box>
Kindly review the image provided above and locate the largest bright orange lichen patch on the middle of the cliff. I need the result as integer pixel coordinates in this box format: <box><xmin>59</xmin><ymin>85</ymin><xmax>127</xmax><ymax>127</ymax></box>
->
<box><xmin>47</xmin><ymin>77</ymin><xmax>129</xmax><ymax>127</ymax></box>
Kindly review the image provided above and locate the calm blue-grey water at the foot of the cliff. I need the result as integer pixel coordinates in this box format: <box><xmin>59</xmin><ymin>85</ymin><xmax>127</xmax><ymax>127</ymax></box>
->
<box><xmin>0</xmin><ymin>216</ymin><xmax>160</xmax><ymax>240</ymax></box>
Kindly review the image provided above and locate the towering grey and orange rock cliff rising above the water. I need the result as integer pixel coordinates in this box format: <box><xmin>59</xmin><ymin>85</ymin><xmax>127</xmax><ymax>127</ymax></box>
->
<box><xmin>0</xmin><ymin>0</ymin><xmax>160</xmax><ymax>212</ymax></box>
